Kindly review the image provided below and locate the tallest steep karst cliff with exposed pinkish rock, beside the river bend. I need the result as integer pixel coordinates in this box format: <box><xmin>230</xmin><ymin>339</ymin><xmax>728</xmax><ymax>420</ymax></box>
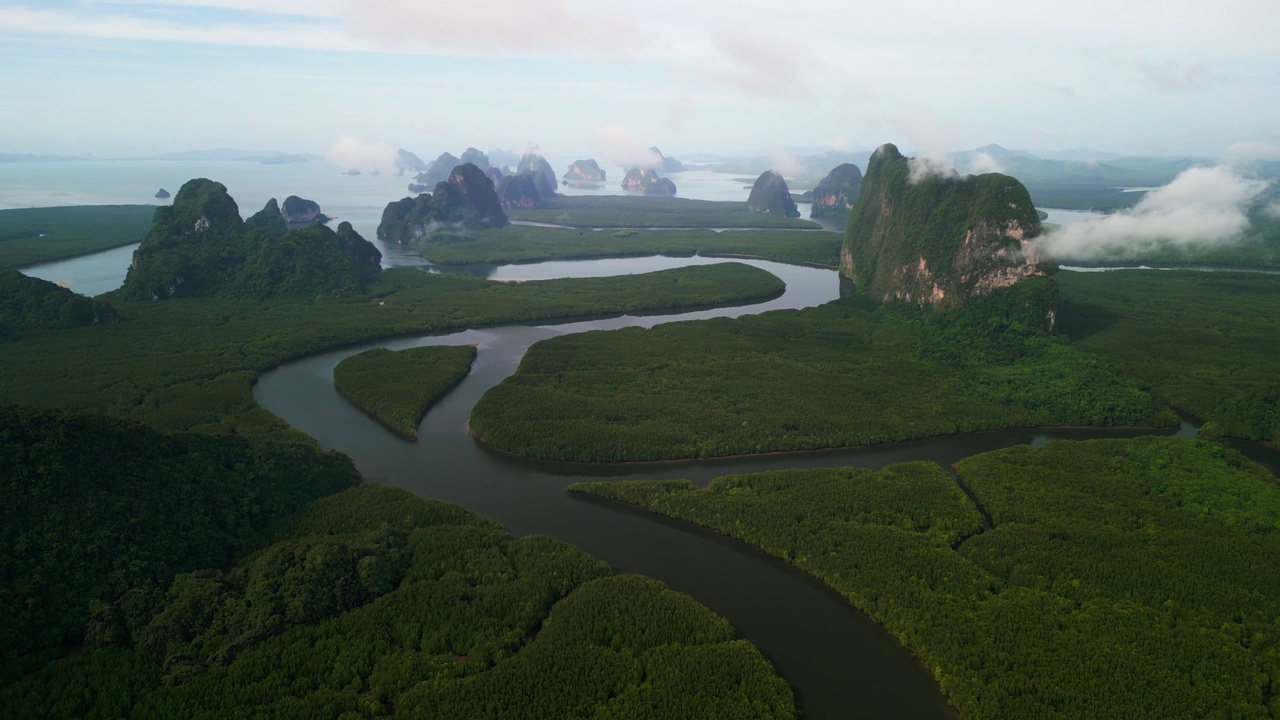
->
<box><xmin>841</xmin><ymin>145</ymin><xmax>1042</xmax><ymax>306</ymax></box>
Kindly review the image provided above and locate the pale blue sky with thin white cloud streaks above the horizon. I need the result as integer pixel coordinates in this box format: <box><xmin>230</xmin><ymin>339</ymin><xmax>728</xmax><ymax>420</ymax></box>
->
<box><xmin>0</xmin><ymin>0</ymin><xmax>1280</xmax><ymax>164</ymax></box>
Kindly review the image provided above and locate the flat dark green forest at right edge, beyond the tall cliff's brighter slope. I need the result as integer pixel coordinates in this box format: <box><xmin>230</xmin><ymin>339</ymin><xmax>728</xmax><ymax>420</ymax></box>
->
<box><xmin>1057</xmin><ymin>270</ymin><xmax>1280</xmax><ymax>443</ymax></box>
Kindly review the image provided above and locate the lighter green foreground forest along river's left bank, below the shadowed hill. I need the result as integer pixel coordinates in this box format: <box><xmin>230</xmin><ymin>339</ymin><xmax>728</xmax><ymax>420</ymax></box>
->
<box><xmin>0</xmin><ymin>474</ymin><xmax>796</xmax><ymax>720</ymax></box>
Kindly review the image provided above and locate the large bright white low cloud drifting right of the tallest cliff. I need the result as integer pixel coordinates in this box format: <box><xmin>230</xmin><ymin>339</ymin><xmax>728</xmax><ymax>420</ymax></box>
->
<box><xmin>1037</xmin><ymin>165</ymin><xmax>1270</xmax><ymax>260</ymax></box>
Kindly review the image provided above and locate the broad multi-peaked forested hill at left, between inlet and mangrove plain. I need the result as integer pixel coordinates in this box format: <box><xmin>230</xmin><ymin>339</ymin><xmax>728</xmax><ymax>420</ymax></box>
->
<box><xmin>116</xmin><ymin>179</ymin><xmax>381</xmax><ymax>300</ymax></box>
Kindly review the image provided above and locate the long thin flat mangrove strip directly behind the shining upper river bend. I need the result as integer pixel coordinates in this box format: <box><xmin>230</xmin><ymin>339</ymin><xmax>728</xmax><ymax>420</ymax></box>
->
<box><xmin>413</xmin><ymin>225</ymin><xmax>844</xmax><ymax>268</ymax></box>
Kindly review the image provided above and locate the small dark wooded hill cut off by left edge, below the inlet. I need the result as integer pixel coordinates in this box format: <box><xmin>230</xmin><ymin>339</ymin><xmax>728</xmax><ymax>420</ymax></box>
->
<box><xmin>0</xmin><ymin>270</ymin><xmax>118</xmax><ymax>341</ymax></box>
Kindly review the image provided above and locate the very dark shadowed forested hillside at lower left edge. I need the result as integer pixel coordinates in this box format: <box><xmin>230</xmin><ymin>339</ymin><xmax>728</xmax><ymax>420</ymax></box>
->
<box><xmin>0</xmin><ymin>406</ymin><xmax>360</xmax><ymax>684</ymax></box>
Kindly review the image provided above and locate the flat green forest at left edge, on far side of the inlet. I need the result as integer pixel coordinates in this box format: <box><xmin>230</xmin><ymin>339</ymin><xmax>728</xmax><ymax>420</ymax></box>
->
<box><xmin>0</xmin><ymin>205</ymin><xmax>156</xmax><ymax>270</ymax></box>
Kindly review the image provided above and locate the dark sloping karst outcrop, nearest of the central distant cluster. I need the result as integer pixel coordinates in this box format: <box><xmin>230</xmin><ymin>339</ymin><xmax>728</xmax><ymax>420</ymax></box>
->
<box><xmin>378</xmin><ymin>163</ymin><xmax>508</xmax><ymax>243</ymax></box>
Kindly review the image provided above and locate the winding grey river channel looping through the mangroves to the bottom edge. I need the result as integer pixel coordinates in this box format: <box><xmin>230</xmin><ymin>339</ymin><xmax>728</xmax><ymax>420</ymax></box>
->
<box><xmin>253</xmin><ymin>258</ymin><xmax>1228</xmax><ymax>719</ymax></box>
